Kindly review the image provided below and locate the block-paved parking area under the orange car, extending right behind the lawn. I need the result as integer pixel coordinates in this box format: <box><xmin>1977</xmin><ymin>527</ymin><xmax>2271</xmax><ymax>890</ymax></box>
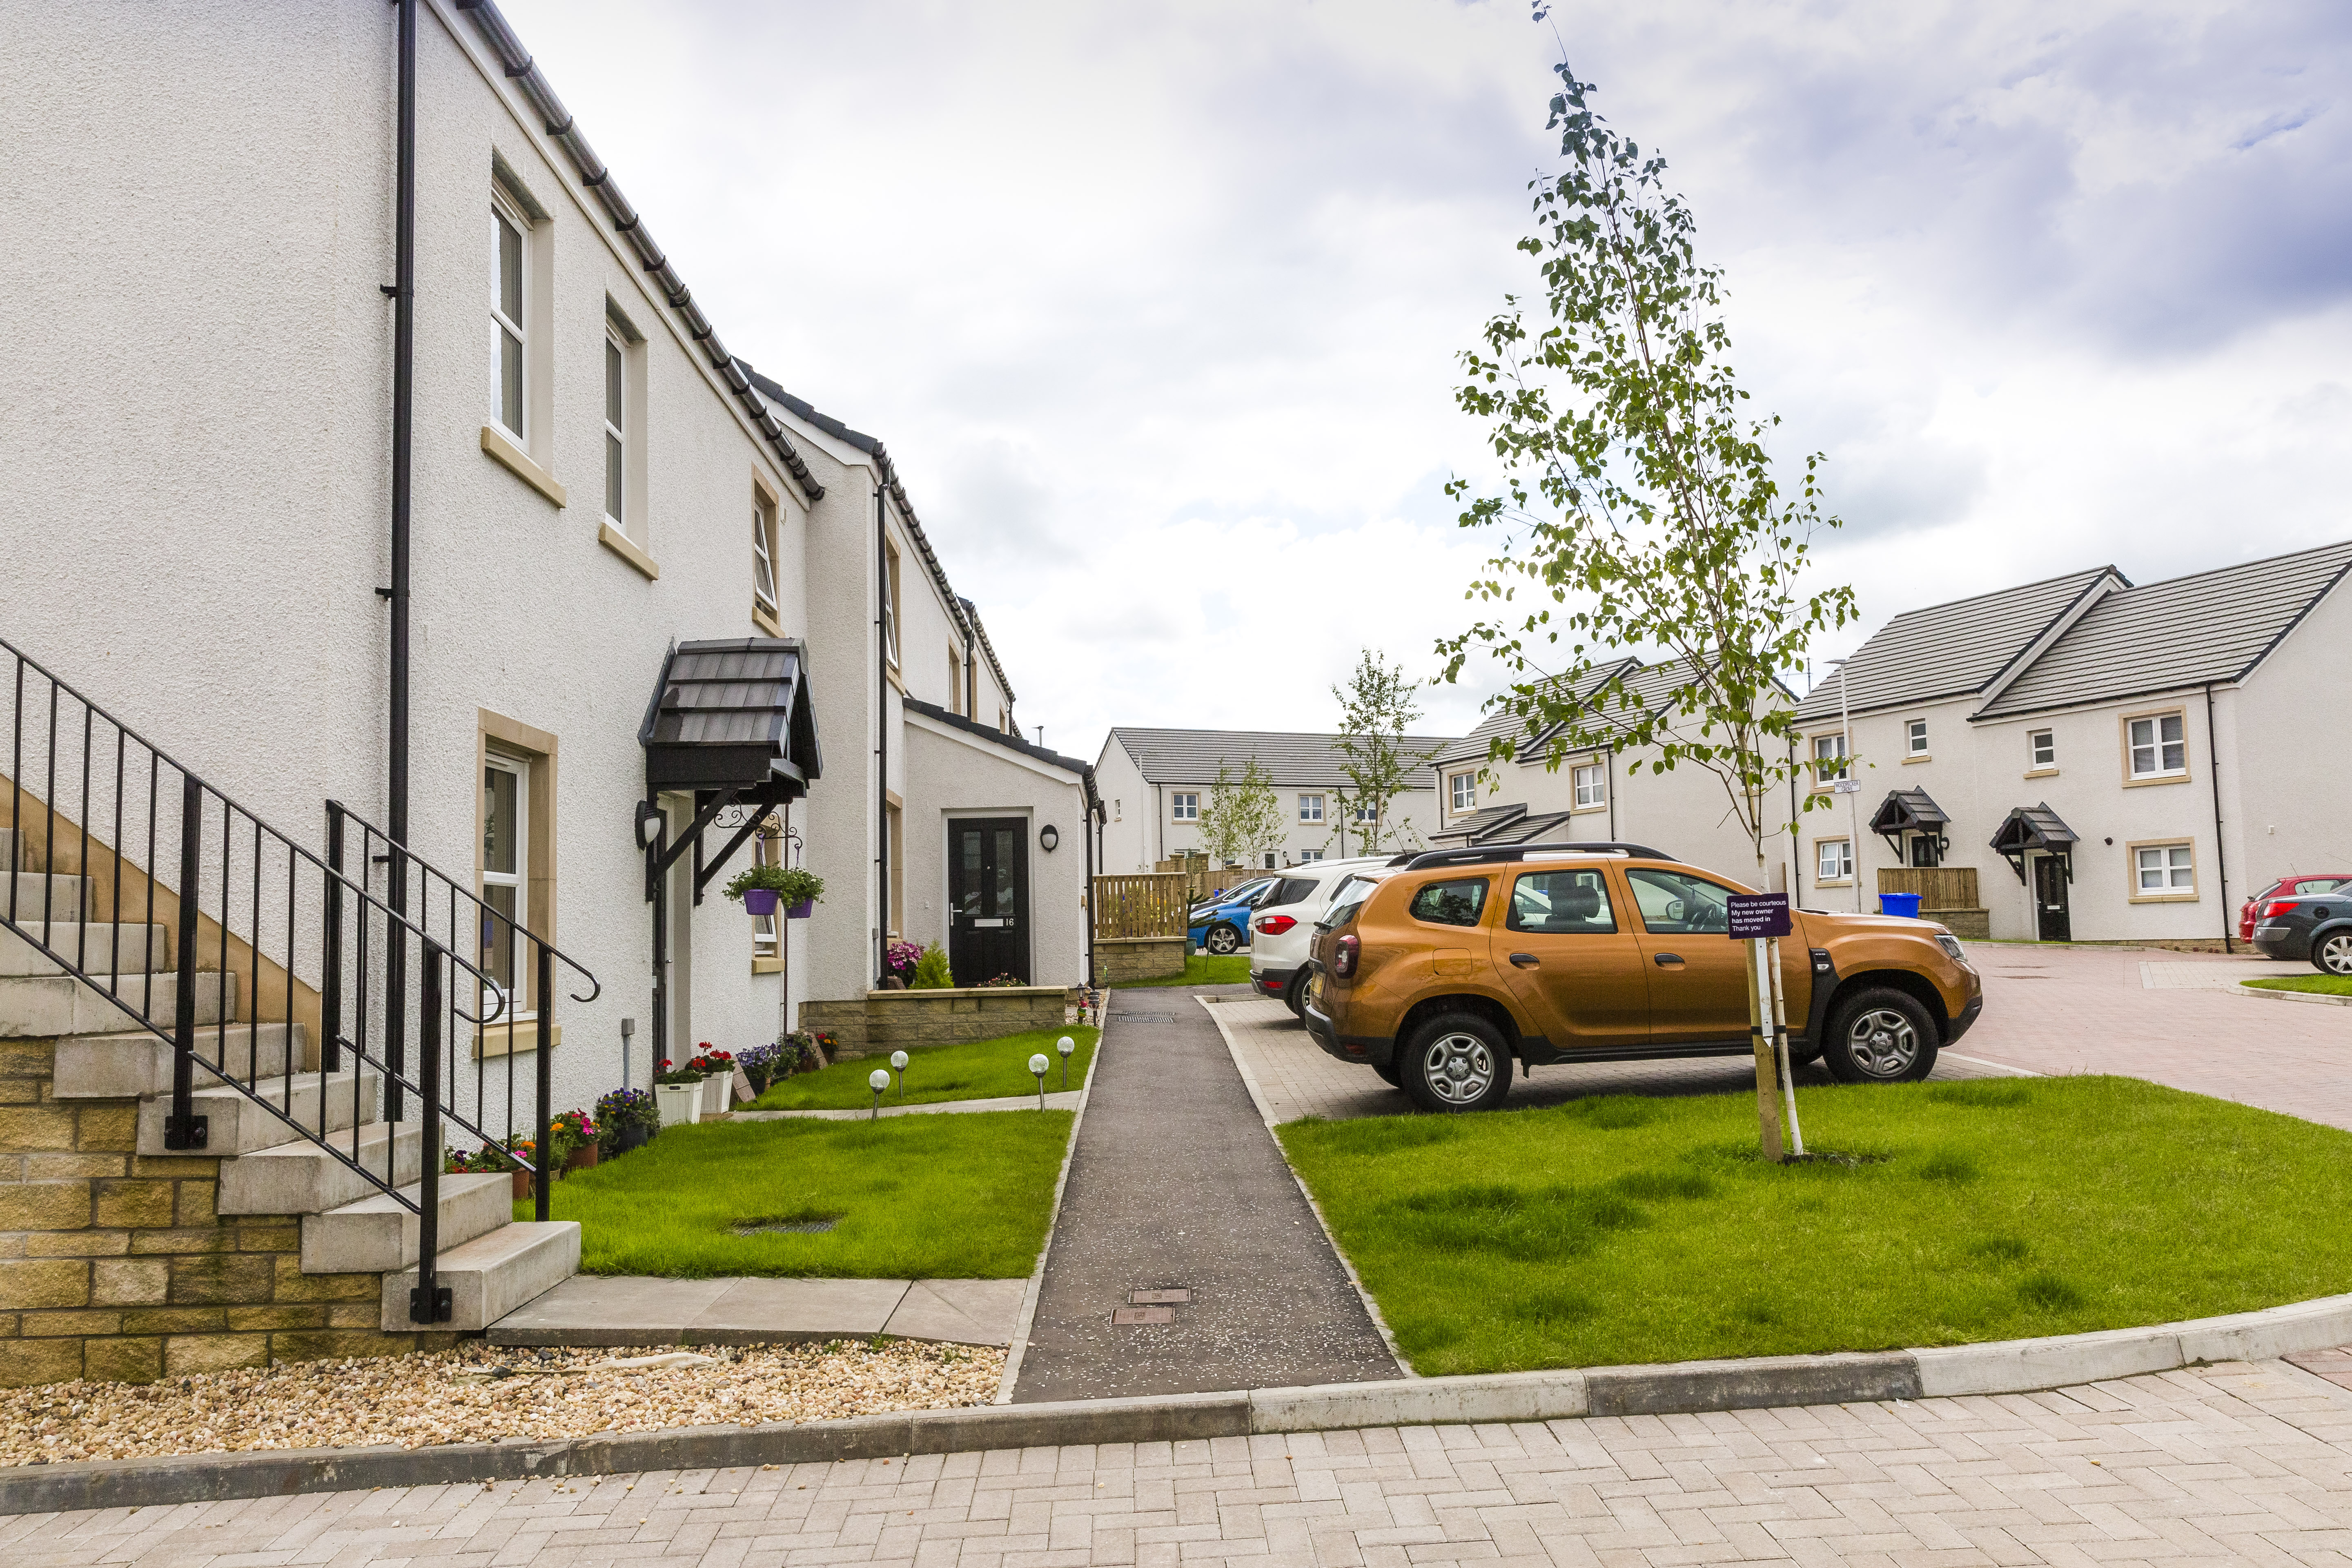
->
<box><xmin>1216</xmin><ymin>943</ymin><xmax>2352</xmax><ymax>1128</ymax></box>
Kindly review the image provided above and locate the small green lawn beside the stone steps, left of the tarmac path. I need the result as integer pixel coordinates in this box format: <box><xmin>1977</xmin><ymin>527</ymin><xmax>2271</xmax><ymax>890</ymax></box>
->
<box><xmin>539</xmin><ymin>1109</ymin><xmax>1073</xmax><ymax>1279</ymax></box>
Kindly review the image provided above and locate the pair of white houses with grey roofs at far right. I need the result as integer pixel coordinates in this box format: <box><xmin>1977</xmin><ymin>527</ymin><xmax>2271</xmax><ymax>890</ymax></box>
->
<box><xmin>1797</xmin><ymin>541</ymin><xmax>2352</xmax><ymax>947</ymax></box>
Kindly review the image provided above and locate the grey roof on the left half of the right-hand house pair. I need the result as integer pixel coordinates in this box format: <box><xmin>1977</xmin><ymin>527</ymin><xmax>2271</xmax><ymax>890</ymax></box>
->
<box><xmin>1797</xmin><ymin>566</ymin><xmax>2126</xmax><ymax>722</ymax></box>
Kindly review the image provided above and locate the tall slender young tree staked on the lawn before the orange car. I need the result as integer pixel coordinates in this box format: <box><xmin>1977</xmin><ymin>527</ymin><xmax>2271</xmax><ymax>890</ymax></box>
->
<box><xmin>1439</xmin><ymin>55</ymin><xmax>1853</xmax><ymax>1152</ymax></box>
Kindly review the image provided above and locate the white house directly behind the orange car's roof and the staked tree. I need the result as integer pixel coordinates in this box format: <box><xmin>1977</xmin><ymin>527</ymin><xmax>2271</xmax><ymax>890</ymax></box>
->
<box><xmin>1430</xmin><ymin>656</ymin><xmax>1795</xmax><ymax>889</ymax></box>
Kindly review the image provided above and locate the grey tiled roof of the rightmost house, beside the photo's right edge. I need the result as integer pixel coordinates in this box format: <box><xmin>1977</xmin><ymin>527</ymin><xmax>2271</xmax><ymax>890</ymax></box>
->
<box><xmin>1978</xmin><ymin>541</ymin><xmax>2352</xmax><ymax>717</ymax></box>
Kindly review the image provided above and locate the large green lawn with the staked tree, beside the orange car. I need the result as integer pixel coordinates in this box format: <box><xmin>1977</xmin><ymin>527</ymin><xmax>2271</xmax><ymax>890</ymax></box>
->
<box><xmin>1277</xmin><ymin>1077</ymin><xmax>2352</xmax><ymax>1375</ymax></box>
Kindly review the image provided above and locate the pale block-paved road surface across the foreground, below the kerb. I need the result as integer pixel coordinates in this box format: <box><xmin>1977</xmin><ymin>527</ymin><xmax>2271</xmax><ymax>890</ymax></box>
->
<box><xmin>13</xmin><ymin>1361</ymin><xmax>2352</xmax><ymax>1568</ymax></box>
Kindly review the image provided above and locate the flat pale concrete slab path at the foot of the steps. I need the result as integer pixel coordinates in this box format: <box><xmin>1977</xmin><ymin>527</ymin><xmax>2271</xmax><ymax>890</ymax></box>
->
<box><xmin>489</xmin><ymin>1274</ymin><xmax>1028</xmax><ymax>1345</ymax></box>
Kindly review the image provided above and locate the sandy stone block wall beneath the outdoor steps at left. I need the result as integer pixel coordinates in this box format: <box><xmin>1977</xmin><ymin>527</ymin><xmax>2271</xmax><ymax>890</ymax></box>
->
<box><xmin>0</xmin><ymin>1039</ymin><xmax>456</xmax><ymax>1387</ymax></box>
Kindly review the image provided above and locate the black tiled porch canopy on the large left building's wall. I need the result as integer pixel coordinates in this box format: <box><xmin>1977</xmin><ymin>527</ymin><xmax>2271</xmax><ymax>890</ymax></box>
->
<box><xmin>637</xmin><ymin>637</ymin><xmax>823</xmax><ymax>903</ymax></box>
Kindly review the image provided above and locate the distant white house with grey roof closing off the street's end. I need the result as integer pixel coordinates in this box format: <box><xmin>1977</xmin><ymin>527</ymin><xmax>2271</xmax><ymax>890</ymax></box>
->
<box><xmin>1094</xmin><ymin>729</ymin><xmax>1454</xmax><ymax>875</ymax></box>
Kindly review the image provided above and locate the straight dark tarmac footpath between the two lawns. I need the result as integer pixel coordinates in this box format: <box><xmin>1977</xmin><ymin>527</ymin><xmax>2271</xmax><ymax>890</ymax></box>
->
<box><xmin>1014</xmin><ymin>987</ymin><xmax>1402</xmax><ymax>1403</ymax></box>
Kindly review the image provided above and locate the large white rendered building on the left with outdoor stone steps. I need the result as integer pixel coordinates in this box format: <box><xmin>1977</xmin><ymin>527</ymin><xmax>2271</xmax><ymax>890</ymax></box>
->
<box><xmin>0</xmin><ymin>0</ymin><xmax>1089</xmax><ymax>1382</ymax></box>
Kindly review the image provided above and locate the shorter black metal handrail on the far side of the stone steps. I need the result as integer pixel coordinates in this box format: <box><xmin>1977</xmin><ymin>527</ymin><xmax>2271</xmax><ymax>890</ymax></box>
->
<box><xmin>327</xmin><ymin>799</ymin><xmax>604</xmax><ymax>1220</ymax></box>
